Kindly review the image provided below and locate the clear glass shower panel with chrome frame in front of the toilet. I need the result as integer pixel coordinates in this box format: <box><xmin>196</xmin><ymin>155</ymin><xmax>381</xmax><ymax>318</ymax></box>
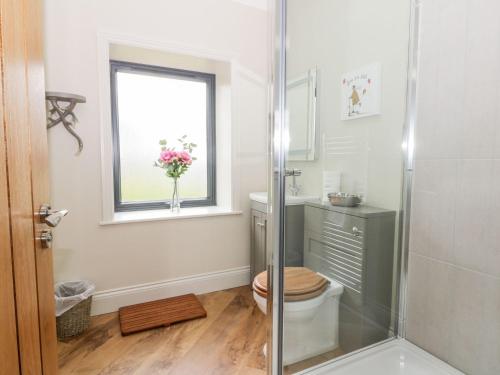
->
<box><xmin>268</xmin><ymin>0</ymin><xmax>415</xmax><ymax>374</ymax></box>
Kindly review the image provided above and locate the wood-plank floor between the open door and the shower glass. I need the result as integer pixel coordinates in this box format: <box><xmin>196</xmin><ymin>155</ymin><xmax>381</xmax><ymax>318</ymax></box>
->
<box><xmin>59</xmin><ymin>287</ymin><xmax>266</xmax><ymax>375</ymax></box>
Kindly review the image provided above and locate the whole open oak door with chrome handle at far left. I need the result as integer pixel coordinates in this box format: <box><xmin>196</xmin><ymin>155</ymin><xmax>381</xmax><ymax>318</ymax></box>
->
<box><xmin>0</xmin><ymin>0</ymin><xmax>57</xmax><ymax>375</ymax></box>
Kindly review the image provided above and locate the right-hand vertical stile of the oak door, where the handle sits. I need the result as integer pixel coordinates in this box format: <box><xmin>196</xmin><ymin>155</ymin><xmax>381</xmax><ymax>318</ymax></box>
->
<box><xmin>24</xmin><ymin>0</ymin><xmax>57</xmax><ymax>375</ymax></box>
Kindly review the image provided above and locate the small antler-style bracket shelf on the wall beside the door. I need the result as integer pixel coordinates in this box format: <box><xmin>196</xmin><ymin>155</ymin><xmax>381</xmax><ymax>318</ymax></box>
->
<box><xmin>45</xmin><ymin>92</ymin><xmax>87</xmax><ymax>154</ymax></box>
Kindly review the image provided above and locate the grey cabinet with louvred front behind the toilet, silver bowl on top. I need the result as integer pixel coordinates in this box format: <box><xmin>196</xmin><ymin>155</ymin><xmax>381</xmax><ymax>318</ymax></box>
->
<box><xmin>304</xmin><ymin>204</ymin><xmax>396</xmax><ymax>351</ymax></box>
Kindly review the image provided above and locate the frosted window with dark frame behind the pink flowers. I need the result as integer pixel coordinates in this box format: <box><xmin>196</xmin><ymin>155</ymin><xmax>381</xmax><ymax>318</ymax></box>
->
<box><xmin>110</xmin><ymin>61</ymin><xmax>216</xmax><ymax>211</ymax></box>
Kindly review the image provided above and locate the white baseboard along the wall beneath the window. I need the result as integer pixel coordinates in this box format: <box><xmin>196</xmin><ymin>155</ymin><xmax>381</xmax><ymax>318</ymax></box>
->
<box><xmin>92</xmin><ymin>267</ymin><xmax>250</xmax><ymax>315</ymax></box>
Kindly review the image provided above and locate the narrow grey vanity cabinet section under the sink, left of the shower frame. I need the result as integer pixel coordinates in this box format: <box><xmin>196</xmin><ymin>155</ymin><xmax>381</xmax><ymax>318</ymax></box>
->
<box><xmin>250</xmin><ymin>209</ymin><xmax>268</xmax><ymax>282</ymax></box>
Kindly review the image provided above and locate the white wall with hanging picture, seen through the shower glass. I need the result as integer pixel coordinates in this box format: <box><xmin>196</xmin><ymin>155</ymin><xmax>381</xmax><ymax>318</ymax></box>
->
<box><xmin>287</xmin><ymin>0</ymin><xmax>410</xmax><ymax>210</ymax></box>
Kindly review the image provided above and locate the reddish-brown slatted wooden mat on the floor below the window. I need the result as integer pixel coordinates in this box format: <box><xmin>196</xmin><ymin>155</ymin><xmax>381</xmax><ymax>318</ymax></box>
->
<box><xmin>118</xmin><ymin>294</ymin><xmax>207</xmax><ymax>335</ymax></box>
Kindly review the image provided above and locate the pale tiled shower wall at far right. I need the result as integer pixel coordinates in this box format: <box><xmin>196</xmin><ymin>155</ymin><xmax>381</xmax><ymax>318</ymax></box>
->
<box><xmin>406</xmin><ymin>0</ymin><xmax>500</xmax><ymax>375</ymax></box>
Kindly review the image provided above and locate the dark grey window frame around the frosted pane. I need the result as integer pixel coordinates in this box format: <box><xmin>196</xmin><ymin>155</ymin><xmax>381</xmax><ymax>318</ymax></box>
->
<box><xmin>109</xmin><ymin>59</ymin><xmax>217</xmax><ymax>212</ymax></box>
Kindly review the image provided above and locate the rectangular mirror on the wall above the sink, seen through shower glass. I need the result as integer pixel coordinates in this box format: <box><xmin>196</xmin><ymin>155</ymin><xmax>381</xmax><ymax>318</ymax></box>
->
<box><xmin>287</xmin><ymin>68</ymin><xmax>317</xmax><ymax>161</ymax></box>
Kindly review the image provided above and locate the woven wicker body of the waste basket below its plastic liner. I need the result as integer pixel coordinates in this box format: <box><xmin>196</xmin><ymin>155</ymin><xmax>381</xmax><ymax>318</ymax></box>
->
<box><xmin>56</xmin><ymin>296</ymin><xmax>92</xmax><ymax>339</ymax></box>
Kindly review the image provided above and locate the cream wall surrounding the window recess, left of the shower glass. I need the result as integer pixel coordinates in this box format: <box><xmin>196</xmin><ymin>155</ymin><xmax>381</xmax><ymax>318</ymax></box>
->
<box><xmin>45</xmin><ymin>0</ymin><xmax>268</xmax><ymax>314</ymax></box>
